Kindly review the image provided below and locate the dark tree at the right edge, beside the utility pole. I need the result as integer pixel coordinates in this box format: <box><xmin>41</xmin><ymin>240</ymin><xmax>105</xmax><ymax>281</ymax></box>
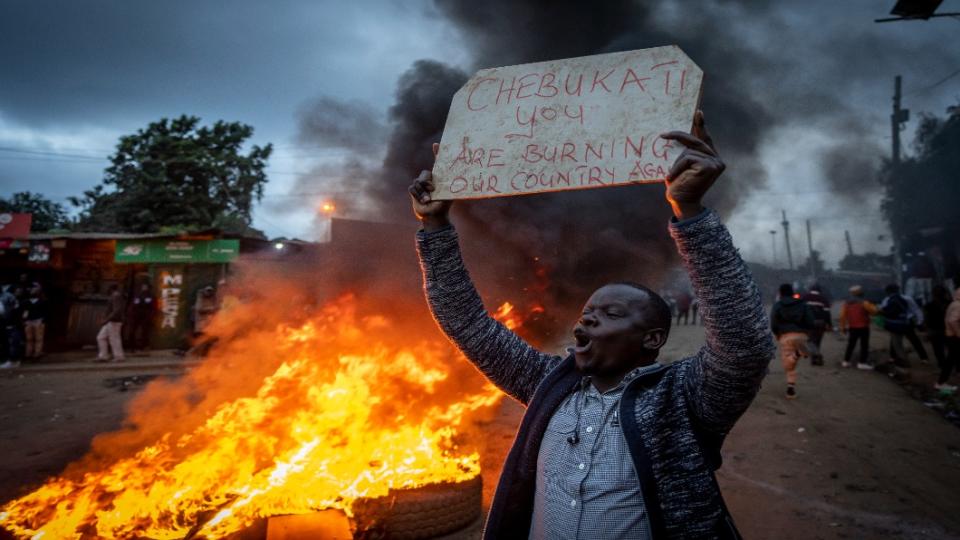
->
<box><xmin>880</xmin><ymin>106</ymin><xmax>960</xmax><ymax>241</ymax></box>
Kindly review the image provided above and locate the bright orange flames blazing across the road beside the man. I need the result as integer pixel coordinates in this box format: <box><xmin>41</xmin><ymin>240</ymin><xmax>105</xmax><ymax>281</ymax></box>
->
<box><xmin>0</xmin><ymin>296</ymin><xmax>519</xmax><ymax>539</ymax></box>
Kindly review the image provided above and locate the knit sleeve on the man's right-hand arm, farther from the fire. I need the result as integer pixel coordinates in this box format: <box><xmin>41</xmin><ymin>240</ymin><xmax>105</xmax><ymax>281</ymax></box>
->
<box><xmin>670</xmin><ymin>210</ymin><xmax>775</xmax><ymax>435</ymax></box>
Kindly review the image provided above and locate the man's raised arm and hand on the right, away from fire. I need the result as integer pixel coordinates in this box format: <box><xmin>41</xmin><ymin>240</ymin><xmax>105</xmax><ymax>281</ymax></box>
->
<box><xmin>664</xmin><ymin>112</ymin><xmax>775</xmax><ymax>436</ymax></box>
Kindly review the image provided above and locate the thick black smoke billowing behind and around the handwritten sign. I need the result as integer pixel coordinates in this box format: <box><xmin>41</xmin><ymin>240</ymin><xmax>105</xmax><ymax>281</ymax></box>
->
<box><xmin>296</xmin><ymin>0</ymin><xmax>956</xmax><ymax>338</ymax></box>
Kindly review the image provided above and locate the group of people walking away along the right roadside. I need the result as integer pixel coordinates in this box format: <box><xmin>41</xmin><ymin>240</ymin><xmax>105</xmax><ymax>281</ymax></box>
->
<box><xmin>770</xmin><ymin>283</ymin><xmax>960</xmax><ymax>399</ymax></box>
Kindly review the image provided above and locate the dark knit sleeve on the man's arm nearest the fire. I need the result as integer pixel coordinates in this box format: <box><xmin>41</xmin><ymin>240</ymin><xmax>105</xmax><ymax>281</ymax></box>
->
<box><xmin>417</xmin><ymin>226</ymin><xmax>560</xmax><ymax>404</ymax></box>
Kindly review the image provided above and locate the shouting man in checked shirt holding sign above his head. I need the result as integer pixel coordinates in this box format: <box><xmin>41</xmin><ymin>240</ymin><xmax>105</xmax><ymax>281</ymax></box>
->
<box><xmin>410</xmin><ymin>111</ymin><xmax>774</xmax><ymax>540</ymax></box>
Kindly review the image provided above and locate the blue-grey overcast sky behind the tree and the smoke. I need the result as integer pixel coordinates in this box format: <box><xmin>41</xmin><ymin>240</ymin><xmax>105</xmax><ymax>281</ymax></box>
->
<box><xmin>0</xmin><ymin>0</ymin><xmax>960</xmax><ymax>264</ymax></box>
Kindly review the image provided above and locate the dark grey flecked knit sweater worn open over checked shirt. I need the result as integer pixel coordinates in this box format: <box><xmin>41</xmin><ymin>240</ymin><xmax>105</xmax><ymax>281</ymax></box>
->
<box><xmin>417</xmin><ymin>210</ymin><xmax>774</xmax><ymax>538</ymax></box>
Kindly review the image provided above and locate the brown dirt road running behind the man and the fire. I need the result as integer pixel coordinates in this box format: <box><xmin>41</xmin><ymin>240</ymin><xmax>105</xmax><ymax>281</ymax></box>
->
<box><xmin>0</xmin><ymin>326</ymin><xmax>960</xmax><ymax>540</ymax></box>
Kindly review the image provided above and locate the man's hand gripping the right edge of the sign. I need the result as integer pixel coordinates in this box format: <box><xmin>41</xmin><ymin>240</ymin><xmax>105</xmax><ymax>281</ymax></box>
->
<box><xmin>660</xmin><ymin>111</ymin><xmax>727</xmax><ymax>219</ymax></box>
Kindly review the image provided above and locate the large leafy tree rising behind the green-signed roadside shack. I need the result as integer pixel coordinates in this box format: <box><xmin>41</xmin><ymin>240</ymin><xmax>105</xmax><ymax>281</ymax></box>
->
<box><xmin>71</xmin><ymin>116</ymin><xmax>273</xmax><ymax>233</ymax></box>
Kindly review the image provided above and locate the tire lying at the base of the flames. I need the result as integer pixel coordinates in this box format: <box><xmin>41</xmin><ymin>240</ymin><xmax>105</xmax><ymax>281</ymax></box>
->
<box><xmin>353</xmin><ymin>476</ymin><xmax>483</xmax><ymax>540</ymax></box>
